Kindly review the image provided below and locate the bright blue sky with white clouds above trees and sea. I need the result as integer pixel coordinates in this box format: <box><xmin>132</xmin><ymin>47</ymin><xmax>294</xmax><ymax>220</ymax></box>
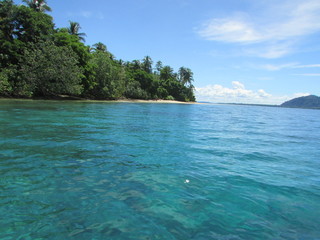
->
<box><xmin>16</xmin><ymin>0</ymin><xmax>320</xmax><ymax>104</ymax></box>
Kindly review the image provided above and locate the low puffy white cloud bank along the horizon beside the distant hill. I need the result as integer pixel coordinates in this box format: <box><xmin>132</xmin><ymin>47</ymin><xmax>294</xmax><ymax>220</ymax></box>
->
<box><xmin>195</xmin><ymin>81</ymin><xmax>310</xmax><ymax>104</ymax></box>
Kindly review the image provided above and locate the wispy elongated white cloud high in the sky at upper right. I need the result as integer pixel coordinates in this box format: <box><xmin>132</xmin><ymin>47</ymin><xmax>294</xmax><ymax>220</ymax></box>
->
<box><xmin>199</xmin><ymin>0</ymin><xmax>320</xmax><ymax>43</ymax></box>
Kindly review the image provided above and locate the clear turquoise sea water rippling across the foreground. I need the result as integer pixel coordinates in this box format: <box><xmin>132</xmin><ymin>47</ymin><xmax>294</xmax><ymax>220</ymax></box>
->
<box><xmin>0</xmin><ymin>100</ymin><xmax>320</xmax><ymax>240</ymax></box>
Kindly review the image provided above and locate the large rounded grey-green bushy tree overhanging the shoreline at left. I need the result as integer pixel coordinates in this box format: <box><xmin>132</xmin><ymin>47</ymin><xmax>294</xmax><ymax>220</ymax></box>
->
<box><xmin>20</xmin><ymin>41</ymin><xmax>82</xmax><ymax>96</ymax></box>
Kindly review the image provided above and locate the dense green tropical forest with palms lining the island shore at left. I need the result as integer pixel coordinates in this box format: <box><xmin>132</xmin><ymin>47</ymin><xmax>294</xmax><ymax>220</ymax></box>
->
<box><xmin>0</xmin><ymin>0</ymin><xmax>195</xmax><ymax>101</ymax></box>
